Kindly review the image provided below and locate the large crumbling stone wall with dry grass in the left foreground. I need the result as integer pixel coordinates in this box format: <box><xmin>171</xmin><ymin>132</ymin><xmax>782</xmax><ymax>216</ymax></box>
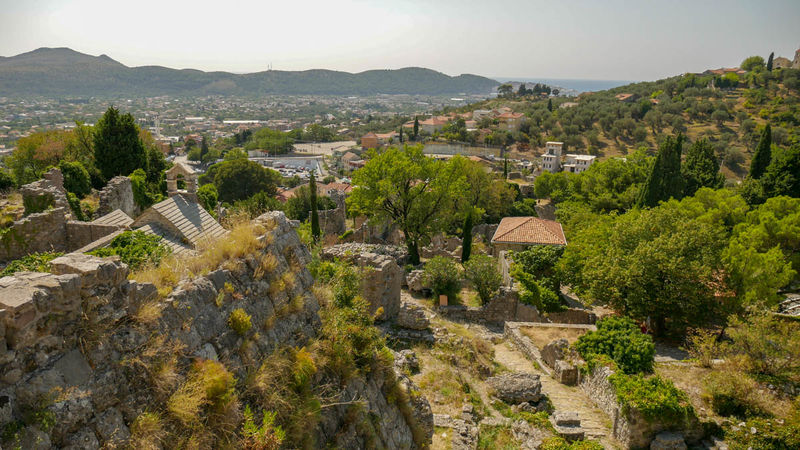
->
<box><xmin>0</xmin><ymin>212</ymin><xmax>433</xmax><ymax>449</ymax></box>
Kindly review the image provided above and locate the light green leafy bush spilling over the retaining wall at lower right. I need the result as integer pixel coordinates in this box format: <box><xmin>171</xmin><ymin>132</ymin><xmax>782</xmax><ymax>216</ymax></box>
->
<box><xmin>609</xmin><ymin>373</ymin><xmax>695</xmax><ymax>424</ymax></box>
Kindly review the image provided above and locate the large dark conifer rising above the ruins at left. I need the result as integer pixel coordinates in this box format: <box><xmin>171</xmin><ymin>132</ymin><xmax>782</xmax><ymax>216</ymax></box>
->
<box><xmin>93</xmin><ymin>106</ymin><xmax>147</xmax><ymax>180</ymax></box>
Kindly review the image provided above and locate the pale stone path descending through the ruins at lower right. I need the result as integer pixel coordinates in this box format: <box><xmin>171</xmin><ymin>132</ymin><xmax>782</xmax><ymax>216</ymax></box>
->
<box><xmin>494</xmin><ymin>342</ymin><xmax>618</xmax><ymax>448</ymax></box>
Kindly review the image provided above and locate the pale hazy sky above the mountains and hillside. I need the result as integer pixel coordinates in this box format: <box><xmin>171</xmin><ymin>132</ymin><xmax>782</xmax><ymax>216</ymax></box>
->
<box><xmin>0</xmin><ymin>0</ymin><xmax>800</xmax><ymax>80</ymax></box>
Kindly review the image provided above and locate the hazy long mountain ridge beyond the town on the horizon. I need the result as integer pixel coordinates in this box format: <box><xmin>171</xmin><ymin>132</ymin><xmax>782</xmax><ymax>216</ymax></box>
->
<box><xmin>0</xmin><ymin>48</ymin><xmax>499</xmax><ymax>97</ymax></box>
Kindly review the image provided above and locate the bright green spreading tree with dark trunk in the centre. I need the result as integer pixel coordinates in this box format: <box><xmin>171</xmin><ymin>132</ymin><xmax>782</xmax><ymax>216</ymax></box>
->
<box><xmin>347</xmin><ymin>145</ymin><xmax>466</xmax><ymax>264</ymax></box>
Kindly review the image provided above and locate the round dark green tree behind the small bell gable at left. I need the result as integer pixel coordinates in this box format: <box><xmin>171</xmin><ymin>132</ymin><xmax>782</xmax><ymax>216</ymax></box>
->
<box><xmin>214</xmin><ymin>159</ymin><xmax>280</xmax><ymax>202</ymax></box>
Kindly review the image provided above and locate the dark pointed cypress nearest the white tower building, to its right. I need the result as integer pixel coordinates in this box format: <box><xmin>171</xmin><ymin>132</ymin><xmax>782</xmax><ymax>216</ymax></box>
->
<box><xmin>636</xmin><ymin>134</ymin><xmax>683</xmax><ymax>207</ymax></box>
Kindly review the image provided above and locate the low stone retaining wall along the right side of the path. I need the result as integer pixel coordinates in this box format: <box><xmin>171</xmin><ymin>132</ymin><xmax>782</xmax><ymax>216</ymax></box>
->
<box><xmin>580</xmin><ymin>366</ymin><xmax>703</xmax><ymax>449</ymax></box>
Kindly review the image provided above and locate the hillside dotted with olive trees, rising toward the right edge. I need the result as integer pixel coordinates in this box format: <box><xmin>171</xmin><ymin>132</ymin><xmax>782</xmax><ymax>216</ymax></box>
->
<box><xmin>446</xmin><ymin>69</ymin><xmax>800</xmax><ymax>178</ymax></box>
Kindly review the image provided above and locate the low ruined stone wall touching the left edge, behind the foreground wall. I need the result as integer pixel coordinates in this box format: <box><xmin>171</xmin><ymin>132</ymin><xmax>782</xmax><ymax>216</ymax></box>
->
<box><xmin>0</xmin><ymin>208</ymin><xmax>67</xmax><ymax>262</ymax></box>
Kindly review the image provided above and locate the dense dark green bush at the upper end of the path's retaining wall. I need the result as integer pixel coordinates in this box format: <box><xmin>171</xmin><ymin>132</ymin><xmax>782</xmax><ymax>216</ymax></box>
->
<box><xmin>574</xmin><ymin>316</ymin><xmax>656</xmax><ymax>374</ymax></box>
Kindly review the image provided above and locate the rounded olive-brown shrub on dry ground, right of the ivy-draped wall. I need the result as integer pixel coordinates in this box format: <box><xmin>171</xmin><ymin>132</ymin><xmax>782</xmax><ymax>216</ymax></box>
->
<box><xmin>703</xmin><ymin>371</ymin><xmax>767</xmax><ymax>418</ymax></box>
